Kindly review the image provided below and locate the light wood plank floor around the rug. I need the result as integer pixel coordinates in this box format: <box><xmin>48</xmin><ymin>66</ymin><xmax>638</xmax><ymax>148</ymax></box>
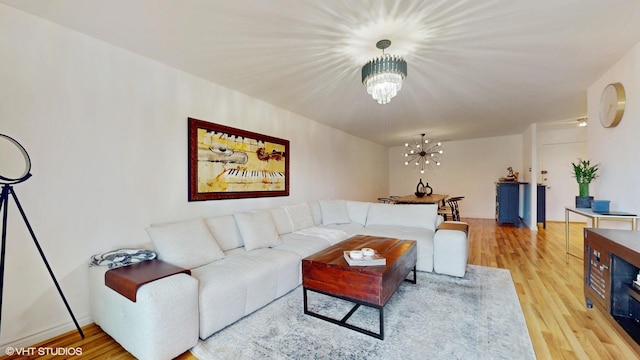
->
<box><xmin>1</xmin><ymin>219</ymin><xmax>640</xmax><ymax>359</ymax></box>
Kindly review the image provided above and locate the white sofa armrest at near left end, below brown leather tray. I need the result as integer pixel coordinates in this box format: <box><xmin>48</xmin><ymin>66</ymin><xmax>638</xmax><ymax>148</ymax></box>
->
<box><xmin>89</xmin><ymin>266</ymin><xmax>199</xmax><ymax>359</ymax></box>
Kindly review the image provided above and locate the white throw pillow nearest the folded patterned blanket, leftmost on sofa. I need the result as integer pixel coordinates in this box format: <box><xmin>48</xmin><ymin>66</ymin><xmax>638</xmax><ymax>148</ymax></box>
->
<box><xmin>146</xmin><ymin>219</ymin><xmax>224</xmax><ymax>269</ymax></box>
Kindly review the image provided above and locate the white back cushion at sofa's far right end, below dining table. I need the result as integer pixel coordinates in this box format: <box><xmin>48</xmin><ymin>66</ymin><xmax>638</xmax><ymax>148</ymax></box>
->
<box><xmin>367</xmin><ymin>203</ymin><xmax>438</xmax><ymax>231</ymax></box>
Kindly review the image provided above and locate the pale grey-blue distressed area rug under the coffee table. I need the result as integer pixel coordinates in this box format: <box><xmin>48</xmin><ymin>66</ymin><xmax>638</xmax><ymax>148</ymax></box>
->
<box><xmin>191</xmin><ymin>265</ymin><xmax>535</xmax><ymax>360</ymax></box>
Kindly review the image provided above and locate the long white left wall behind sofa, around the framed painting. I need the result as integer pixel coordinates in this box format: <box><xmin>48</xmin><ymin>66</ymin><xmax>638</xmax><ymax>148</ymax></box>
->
<box><xmin>0</xmin><ymin>5</ymin><xmax>388</xmax><ymax>344</ymax></box>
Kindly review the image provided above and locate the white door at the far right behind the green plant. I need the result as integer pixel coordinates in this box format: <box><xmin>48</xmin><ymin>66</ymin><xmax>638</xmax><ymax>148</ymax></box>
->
<box><xmin>541</xmin><ymin>141</ymin><xmax>587</xmax><ymax>221</ymax></box>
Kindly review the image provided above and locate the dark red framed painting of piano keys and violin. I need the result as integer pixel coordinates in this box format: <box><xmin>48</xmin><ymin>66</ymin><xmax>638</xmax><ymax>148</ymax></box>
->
<box><xmin>188</xmin><ymin>118</ymin><xmax>290</xmax><ymax>201</ymax></box>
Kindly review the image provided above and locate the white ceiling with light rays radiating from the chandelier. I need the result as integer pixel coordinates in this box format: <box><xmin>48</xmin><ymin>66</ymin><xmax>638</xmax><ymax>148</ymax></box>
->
<box><xmin>5</xmin><ymin>0</ymin><xmax>640</xmax><ymax>146</ymax></box>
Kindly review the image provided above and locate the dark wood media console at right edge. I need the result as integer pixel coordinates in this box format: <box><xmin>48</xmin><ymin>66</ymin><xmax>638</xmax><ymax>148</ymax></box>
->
<box><xmin>584</xmin><ymin>229</ymin><xmax>640</xmax><ymax>354</ymax></box>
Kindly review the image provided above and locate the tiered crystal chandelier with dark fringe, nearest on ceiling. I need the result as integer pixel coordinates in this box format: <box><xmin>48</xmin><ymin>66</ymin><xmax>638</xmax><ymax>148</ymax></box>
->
<box><xmin>362</xmin><ymin>40</ymin><xmax>407</xmax><ymax>104</ymax></box>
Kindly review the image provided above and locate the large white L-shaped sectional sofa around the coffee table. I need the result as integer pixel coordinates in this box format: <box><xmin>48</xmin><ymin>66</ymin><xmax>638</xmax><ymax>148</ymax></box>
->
<box><xmin>90</xmin><ymin>200</ymin><xmax>468</xmax><ymax>359</ymax></box>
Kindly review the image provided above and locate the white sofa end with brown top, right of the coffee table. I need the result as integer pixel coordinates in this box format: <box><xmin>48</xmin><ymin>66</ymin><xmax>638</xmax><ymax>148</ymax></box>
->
<box><xmin>433</xmin><ymin>221</ymin><xmax>469</xmax><ymax>277</ymax></box>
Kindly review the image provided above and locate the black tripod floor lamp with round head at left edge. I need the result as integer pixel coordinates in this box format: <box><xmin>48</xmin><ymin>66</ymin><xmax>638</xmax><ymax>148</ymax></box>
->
<box><xmin>0</xmin><ymin>134</ymin><xmax>84</xmax><ymax>338</ymax></box>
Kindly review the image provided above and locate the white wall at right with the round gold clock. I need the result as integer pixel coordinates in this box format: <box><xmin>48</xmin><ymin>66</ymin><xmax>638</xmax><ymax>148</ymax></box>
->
<box><xmin>587</xmin><ymin>38</ymin><xmax>640</xmax><ymax>228</ymax></box>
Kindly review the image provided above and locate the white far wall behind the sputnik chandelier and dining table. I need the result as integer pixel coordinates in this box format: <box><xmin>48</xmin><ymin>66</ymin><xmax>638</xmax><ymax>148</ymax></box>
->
<box><xmin>389</xmin><ymin>135</ymin><xmax>523</xmax><ymax>219</ymax></box>
